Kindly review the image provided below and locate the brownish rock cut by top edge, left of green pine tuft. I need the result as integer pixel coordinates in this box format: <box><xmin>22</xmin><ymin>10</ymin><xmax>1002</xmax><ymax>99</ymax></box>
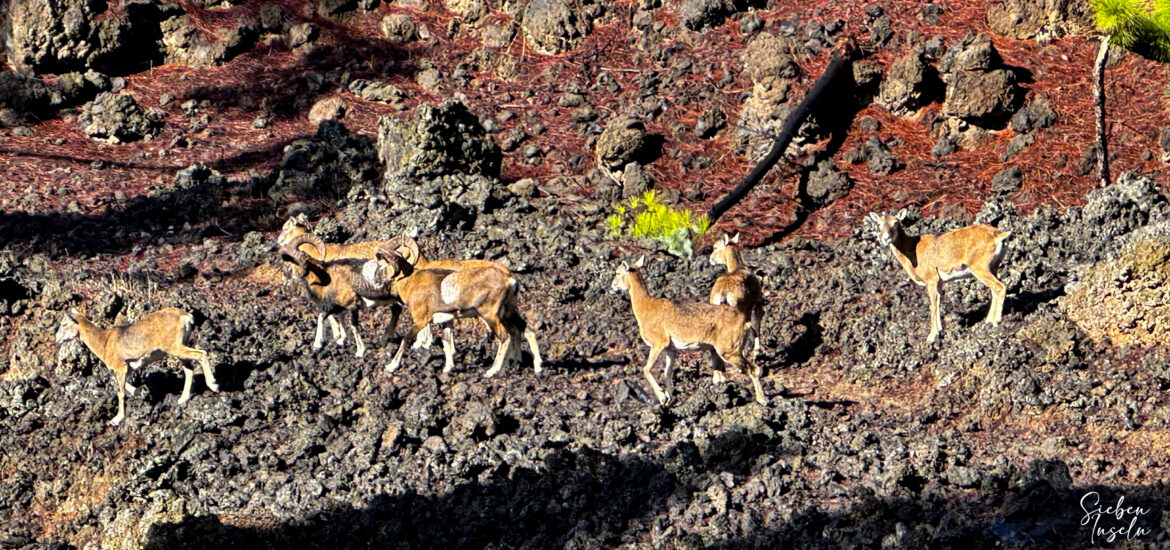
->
<box><xmin>987</xmin><ymin>0</ymin><xmax>1093</xmax><ymax>40</ymax></box>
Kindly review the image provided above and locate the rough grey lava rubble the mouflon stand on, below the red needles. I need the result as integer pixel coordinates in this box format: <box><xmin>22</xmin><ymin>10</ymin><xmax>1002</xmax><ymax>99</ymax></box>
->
<box><xmin>0</xmin><ymin>167</ymin><xmax>1170</xmax><ymax>549</ymax></box>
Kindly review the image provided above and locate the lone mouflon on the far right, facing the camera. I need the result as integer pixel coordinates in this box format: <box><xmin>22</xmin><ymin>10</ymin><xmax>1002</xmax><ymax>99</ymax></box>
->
<box><xmin>866</xmin><ymin>209</ymin><xmax>1011</xmax><ymax>342</ymax></box>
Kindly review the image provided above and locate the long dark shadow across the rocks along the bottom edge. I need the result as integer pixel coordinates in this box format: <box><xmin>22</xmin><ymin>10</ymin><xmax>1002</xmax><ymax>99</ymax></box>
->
<box><xmin>132</xmin><ymin>451</ymin><xmax>1170</xmax><ymax>549</ymax></box>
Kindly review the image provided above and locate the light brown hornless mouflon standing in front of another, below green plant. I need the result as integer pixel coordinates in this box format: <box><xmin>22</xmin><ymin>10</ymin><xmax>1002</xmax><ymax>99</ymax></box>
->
<box><xmin>610</xmin><ymin>257</ymin><xmax>768</xmax><ymax>405</ymax></box>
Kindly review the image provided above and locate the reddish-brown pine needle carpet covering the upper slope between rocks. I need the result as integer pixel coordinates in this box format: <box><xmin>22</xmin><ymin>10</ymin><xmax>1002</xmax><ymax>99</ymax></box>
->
<box><xmin>0</xmin><ymin>0</ymin><xmax>1168</xmax><ymax>249</ymax></box>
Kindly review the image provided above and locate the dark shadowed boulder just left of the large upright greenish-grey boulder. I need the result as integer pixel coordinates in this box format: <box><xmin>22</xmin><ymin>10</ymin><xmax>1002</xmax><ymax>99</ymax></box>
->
<box><xmin>268</xmin><ymin>119</ymin><xmax>378</xmax><ymax>204</ymax></box>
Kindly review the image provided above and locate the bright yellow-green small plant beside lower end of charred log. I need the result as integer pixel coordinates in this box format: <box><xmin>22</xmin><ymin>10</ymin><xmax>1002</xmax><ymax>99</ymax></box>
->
<box><xmin>606</xmin><ymin>191</ymin><xmax>711</xmax><ymax>256</ymax></box>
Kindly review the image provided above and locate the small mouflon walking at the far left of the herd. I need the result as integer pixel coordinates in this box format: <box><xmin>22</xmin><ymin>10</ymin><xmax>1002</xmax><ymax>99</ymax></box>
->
<box><xmin>56</xmin><ymin>308</ymin><xmax>219</xmax><ymax>426</ymax></box>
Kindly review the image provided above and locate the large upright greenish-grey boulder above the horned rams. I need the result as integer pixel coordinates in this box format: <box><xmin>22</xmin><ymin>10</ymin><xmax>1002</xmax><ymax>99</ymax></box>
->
<box><xmin>378</xmin><ymin>101</ymin><xmax>502</xmax><ymax>181</ymax></box>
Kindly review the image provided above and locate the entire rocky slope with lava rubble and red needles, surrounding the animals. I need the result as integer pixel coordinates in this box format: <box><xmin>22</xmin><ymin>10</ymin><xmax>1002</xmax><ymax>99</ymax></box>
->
<box><xmin>0</xmin><ymin>0</ymin><xmax>1170</xmax><ymax>549</ymax></box>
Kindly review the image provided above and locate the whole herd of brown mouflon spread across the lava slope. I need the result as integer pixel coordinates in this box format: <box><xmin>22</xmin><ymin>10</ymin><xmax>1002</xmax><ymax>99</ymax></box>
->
<box><xmin>56</xmin><ymin>211</ymin><xmax>1010</xmax><ymax>426</ymax></box>
